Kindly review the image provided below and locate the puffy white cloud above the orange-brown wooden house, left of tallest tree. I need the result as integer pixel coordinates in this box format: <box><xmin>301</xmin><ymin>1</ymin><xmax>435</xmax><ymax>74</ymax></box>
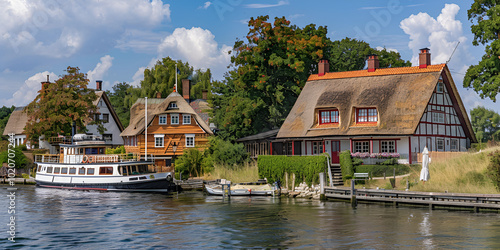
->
<box><xmin>158</xmin><ymin>27</ymin><xmax>232</xmax><ymax>79</ymax></box>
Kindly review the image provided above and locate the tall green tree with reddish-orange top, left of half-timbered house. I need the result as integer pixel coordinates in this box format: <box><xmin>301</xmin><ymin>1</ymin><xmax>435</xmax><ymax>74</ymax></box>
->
<box><xmin>212</xmin><ymin>16</ymin><xmax>327</xmax><ymax>140</ymax></box>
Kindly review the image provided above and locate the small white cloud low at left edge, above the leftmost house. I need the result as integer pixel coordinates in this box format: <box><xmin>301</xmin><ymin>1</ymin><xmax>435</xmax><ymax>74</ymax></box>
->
<box><xmin>0</xmin><ymin>71</ymin><xmax>59</xmax><ymax>107</ymax></box>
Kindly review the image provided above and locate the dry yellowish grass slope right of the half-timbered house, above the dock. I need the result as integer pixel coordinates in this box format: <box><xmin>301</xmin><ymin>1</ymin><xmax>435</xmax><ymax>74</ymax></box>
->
<box><xmin>364</xmin><ymin>147</ymin><xmax>500</xmax><ymax>194</ymax></box>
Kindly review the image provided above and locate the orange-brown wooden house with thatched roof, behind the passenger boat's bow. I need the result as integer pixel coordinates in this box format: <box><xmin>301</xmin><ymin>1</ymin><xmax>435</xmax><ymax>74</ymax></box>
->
<box><xmin>121</xmin><ymin>81</ymin><xmax>213</xmax><ymax>166</ymax></box>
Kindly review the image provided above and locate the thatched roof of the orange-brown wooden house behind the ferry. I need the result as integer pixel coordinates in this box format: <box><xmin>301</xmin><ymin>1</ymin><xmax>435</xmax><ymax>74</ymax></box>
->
<box><xmin>120</xmin><ymin>92</ymin><xmax>213</xmax><ymax>136</ymax></box>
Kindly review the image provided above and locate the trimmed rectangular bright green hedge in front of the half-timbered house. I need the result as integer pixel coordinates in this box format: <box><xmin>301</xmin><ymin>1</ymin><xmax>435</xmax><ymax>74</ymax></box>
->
<box><xmin>257</xmin><ymin>155</ymin><xmax>328</xmax><ymax>185</ymax></box>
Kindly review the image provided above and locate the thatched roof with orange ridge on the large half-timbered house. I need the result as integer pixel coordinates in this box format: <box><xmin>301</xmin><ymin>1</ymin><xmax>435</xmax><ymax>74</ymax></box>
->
<box><xmin>277</xmin><ymin>64</ymin><xmax>475</xmax><ymax>141</ymax></box>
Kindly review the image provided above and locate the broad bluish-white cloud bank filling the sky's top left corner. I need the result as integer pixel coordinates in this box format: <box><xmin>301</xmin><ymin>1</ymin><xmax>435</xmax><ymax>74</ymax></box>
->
<box><xmin>0</xmin><ymin>0</ymin><xmax>170</xmax><ymax>70</ymax></box>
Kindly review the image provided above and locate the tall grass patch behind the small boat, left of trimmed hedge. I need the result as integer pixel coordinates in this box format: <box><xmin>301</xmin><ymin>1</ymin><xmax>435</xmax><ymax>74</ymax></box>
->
<box><xmin>201</xmin><ymin>161</ymin><xmax>259</xmax><ymax>183</ymax></box>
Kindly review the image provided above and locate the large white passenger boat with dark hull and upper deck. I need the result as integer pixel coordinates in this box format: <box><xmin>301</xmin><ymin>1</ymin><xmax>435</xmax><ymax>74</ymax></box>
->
<box><xmin>35</xmin><ymin>138</ymin><xmax>175</xmax><ymax>192</ymax></box>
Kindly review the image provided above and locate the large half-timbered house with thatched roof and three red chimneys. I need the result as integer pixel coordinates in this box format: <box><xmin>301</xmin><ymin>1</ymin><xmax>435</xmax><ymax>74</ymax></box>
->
<box><xmin>276</xmin><ymin>48</ymin><xmax>476</xmax><ymax>163</ymax></box>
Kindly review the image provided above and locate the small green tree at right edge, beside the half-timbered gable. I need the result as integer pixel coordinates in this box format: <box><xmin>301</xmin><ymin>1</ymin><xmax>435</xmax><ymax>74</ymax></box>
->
<box><xmin>470</xmin><ymin>107</ymin><xmax>500</xmax><ymax>142</ymax></box>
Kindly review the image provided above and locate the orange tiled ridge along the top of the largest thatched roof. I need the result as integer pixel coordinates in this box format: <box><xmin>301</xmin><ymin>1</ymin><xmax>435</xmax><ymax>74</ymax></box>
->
<box><xmin>307</xmin><ymin>63</ymin><xmax>446</xmax><ymax>81</ymax></box>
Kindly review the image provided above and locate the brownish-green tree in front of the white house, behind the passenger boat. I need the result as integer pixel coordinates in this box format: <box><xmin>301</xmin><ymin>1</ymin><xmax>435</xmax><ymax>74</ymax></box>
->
<box><xmin>25</xmin><ymin>67</ymin><xmax>104</xmax><ymax>145</ymax></box>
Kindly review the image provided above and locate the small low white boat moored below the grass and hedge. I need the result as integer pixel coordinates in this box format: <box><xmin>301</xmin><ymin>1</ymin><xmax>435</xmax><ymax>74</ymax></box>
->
<box><xmin>205</xmin><ymin>184</ymin><xmax>279</xmax><ymax>196</ymax></box>
